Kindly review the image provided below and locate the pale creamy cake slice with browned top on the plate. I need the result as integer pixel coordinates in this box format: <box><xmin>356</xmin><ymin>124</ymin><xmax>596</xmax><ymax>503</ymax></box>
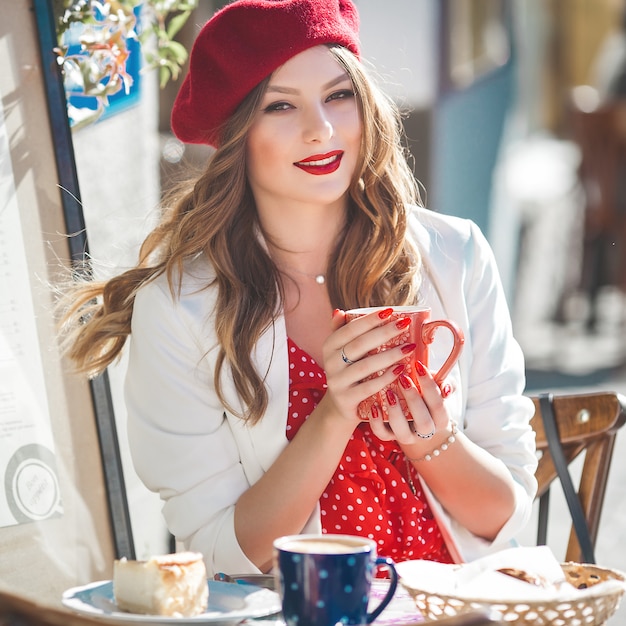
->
<box><xmin>113</xmin><ymin>552</ymin><xmax>209</xmax><ymax>617</ymax></box>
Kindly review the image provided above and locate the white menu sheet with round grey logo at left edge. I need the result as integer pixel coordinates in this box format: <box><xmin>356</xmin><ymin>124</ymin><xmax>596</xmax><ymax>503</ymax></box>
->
<box><xmin>0</xmin><ymin>94</ymin><xmax>62</xmax><ymax>526</ymax></box>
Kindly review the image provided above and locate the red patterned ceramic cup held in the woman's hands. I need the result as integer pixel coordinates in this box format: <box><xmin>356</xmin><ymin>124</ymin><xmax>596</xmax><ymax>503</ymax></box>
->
<box><xmin>346</xmin><ymin>306</ymin><xmax>465</xmax><ymax>420</ymax></box>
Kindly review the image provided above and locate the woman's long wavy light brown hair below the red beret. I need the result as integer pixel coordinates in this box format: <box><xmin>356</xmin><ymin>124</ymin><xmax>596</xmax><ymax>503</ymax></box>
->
<box><xmin>61</xmin><ymin>46</ymin><xmax>421</xmax><ymax>423</ymax></box>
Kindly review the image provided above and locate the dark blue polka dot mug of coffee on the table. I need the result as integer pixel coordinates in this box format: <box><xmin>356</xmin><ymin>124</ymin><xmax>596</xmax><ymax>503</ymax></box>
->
<box><xmin>274</xmin><ymin>535</ymin><xmax>398</xmax><ymax>626</ymax></box>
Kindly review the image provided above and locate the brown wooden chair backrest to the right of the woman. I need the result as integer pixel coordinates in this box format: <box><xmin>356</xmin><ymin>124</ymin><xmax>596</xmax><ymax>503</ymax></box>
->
<box><xmin>531</xmin><ymin>392</ymin><xmax>626</xmax><ymax>562</ymax></box>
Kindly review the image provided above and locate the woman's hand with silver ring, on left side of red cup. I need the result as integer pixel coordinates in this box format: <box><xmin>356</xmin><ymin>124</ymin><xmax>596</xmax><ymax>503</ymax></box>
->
<box><xmin>323</xmin><ymin>307</ymin><xmax>415</xmax><ymax>422</ymax></box>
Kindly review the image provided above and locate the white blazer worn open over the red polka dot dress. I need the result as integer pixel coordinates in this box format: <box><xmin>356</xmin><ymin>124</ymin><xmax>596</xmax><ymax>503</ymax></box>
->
<box><xmin>125</xmin><ymin>208</ymin><xmax>537</xmax><ymax>575</ymax></box>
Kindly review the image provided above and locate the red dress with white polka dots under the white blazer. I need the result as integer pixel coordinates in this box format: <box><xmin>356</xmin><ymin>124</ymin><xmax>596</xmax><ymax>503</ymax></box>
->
<box><xmin>287</xmin><ymin>339</ymin><xmax>452</xmax><ymax>563</ymax></box>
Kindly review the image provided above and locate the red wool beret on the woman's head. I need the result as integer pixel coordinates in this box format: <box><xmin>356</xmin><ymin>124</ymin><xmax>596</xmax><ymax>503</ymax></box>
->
<box><xmin>171</xmin><ymin>0</ymin><xmax>360</xmax><ymax>146</ymax></box>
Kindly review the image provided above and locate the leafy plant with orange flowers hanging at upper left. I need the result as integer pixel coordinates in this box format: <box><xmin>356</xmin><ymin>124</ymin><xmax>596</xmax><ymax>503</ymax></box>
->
<box><xmin>54</xmin><ymin>0</ymin><xmax>197</xmax><ymax>128</ymax></box>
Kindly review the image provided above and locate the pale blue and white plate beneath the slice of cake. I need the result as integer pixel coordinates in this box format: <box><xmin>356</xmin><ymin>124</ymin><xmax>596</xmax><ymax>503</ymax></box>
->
<box><xmin>63</xmin><ymin>580</ymin><xmax>281</xmax><ymax>625</ymax></box>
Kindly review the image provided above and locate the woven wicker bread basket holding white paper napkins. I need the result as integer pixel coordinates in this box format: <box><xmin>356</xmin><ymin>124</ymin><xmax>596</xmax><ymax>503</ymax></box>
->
<box><xmin>400</xmin><ymin>563</ymin><xmax>626</xmax><ymax>626</ymax></box>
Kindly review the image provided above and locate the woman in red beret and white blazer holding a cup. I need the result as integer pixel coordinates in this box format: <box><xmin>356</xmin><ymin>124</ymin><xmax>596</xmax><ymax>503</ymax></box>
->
<box><xmin>59</xmin><ymin>0</ymin><xmax>536</xmax><ymax>572</ymax></box>
